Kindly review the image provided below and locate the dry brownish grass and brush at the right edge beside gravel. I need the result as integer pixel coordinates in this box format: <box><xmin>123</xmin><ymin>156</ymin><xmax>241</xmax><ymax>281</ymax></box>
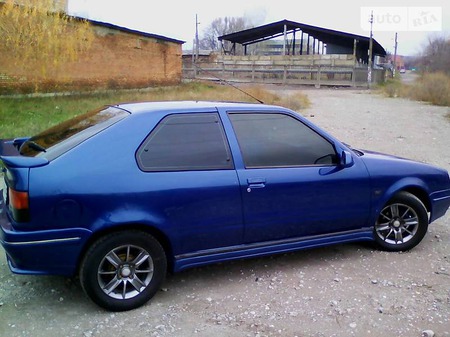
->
<box><xmin>379</xmin><ymin>73</ymin><xmax>450</xmax><ymax>106</ymax></box>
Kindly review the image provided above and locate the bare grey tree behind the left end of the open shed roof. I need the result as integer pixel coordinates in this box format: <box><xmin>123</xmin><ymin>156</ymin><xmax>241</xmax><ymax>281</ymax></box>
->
<box><xmin>199</xmin><ymin>17</ymin><xmax>251</xmax><ymax>50</ymax></box>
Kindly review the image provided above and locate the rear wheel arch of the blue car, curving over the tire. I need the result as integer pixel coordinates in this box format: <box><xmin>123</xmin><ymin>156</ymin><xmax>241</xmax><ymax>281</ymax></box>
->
<box><xmin>76</xmin><ymin>223</ymin><xmax>174</xmax><ymax>272</ymax></box>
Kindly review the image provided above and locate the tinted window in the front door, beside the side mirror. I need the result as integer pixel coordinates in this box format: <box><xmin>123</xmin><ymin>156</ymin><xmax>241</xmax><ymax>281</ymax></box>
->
<box><xmin>229</xmin><ymin>113</ymin><xmax>336</xmax><ymax>168</ymax></box>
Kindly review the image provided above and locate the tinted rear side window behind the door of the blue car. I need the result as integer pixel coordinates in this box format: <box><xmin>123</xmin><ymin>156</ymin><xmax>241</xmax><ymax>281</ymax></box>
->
<box><xmin>136</xmin><ymin>113</ymin><xmax>234</xmax><ymax>171</ymax></box>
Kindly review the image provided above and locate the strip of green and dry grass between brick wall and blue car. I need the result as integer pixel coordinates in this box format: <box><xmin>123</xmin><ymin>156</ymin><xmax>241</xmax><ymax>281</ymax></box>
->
<box><xmin>0</xmin><ymin>82</ymin><xmax>309</xmax><ymax>138</ymax></box>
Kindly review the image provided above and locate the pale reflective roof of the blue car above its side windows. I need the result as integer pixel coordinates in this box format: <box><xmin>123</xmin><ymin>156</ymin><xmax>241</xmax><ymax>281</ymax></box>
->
<box><xmin>111</xmin><ymin>101</ymin><xmax>281</xmax><ymax>114</ymax></box>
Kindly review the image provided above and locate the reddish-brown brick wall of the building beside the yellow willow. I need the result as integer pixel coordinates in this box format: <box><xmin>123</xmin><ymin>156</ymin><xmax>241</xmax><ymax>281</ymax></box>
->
<box><xmin>0</xmin><ymin>22</ymin><xmax>182</xmax><ymax>93</ymax></box>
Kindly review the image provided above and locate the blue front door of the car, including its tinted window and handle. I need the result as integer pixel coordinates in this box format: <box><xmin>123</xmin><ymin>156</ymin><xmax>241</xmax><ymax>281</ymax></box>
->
<box><xmin>228</xmin><ymin>112</ymin><xmax>370</xmax><ymax>243</ymax></box>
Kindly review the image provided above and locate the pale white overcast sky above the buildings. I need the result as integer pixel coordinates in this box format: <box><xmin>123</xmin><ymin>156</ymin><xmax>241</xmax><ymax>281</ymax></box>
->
<box><xmin>68</xmin><ymin>0</ymin><xmax>450</xmax><ymax>55</ymax></box>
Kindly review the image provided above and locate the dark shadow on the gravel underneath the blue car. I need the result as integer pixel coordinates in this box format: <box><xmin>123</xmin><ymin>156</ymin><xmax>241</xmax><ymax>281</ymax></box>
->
<box><xmin>0</xmin><ymin>243</ymin><xmax>380</xmax><ymax>314</ymax></box>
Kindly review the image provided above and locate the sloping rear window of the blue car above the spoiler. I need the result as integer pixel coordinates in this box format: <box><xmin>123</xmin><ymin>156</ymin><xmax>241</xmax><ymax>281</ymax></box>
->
<box><xmin>20</xmin><ymin>107</ymin><xmax>129</xmax><ymax>160</ymax></box>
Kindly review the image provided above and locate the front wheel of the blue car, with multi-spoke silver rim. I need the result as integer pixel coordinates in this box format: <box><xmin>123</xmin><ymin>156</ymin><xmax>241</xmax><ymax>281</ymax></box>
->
<box><xmin>374</xmin><ymin>192</ymin><xmax>428</xmax><ymax>252</ymax></box>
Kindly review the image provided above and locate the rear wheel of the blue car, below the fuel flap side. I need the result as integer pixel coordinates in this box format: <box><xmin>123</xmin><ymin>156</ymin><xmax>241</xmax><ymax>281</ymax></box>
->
<box><xmin>79</xmin><ymin>230</ymin><xmax>167</xmax><ymax>311</ymax></box>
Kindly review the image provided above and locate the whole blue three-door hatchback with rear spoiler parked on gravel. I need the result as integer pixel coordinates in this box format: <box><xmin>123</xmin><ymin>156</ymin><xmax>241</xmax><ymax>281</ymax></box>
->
<box><xmin>0</xmin><ymin>102</ymin><xmax>450</xmax><ymax>311</ymax></box>
